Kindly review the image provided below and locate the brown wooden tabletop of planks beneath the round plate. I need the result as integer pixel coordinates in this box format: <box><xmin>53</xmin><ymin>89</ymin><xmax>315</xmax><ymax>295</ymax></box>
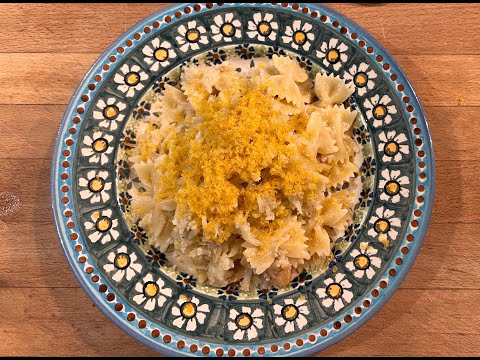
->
<box><xmin>0</xmin><ymin>4</ymin><xmax>480</xmax><ymax>356</ymax></box>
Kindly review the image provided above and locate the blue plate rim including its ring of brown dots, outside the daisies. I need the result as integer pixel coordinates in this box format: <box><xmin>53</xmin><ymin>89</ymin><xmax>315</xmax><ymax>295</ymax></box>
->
<box><xmin>51</xmin><ymin>3</ymin><xmax>435</xmax><ymax>356</ymax></box>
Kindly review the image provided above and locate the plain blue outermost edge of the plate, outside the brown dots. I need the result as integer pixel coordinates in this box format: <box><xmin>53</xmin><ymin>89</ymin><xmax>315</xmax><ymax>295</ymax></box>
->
<box><xmin>50</xmin><ymin>3</ymin><xmax>436</xmax><ymax>356</ymax></box>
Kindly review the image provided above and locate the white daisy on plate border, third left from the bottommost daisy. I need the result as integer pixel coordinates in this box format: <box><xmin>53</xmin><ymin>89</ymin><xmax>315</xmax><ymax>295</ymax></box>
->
<box><xmin>103</xmin><ymin>245</ymin><xmax>142</xmax><ymax>282</ymax></box>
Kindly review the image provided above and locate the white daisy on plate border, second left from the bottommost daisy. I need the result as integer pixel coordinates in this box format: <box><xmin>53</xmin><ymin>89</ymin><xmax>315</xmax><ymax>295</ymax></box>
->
<box><xmin>133</xmin><ymin>273</ymin><xmax>172</xmax><ymax>311</ymax></box>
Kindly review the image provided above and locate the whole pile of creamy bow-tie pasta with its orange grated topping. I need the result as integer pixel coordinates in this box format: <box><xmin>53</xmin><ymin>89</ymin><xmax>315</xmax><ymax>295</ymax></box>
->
<box><xmin>129</xmin><ymin>55</ymin><xmax>360</xmax><ymax>290</ymax></box>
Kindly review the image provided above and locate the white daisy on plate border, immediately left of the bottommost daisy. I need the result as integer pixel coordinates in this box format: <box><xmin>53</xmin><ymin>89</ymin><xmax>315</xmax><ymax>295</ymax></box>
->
<box><xmin>172</xmin><ymin>295</ymin><xmax>210</xmax><ymax>331</ymax></box>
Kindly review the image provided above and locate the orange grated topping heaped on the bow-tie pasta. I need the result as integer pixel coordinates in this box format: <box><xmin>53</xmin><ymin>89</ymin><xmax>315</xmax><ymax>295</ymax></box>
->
<box><xmin>156</xmin><ymin>78</ymin><xmax>324</xmax><ymax>243</ymax></box>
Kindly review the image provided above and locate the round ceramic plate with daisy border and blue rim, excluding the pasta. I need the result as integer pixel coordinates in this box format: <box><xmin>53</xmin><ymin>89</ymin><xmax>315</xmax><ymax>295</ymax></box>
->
<box><xmin>51</xmin><ymin>3</ymin><xmax>435</xmax><ymax>356</ymax></box>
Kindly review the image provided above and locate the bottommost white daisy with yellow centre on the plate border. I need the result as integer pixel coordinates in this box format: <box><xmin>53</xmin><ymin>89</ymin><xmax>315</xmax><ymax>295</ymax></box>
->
<box><xmin>227</xmin><ymin>306</ymin><xmax>265</xmax><ymax>340</ymax></box>
